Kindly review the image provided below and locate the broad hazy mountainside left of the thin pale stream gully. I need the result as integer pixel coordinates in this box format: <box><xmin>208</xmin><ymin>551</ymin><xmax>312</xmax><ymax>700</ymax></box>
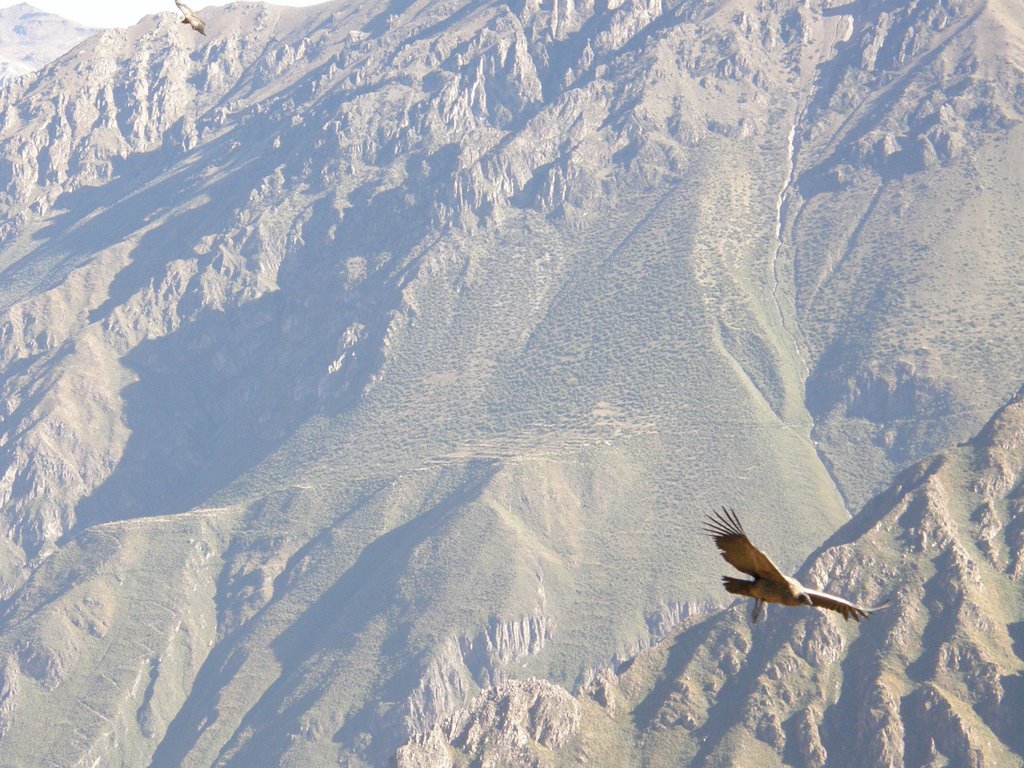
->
<box><xmin>0</xmin><ymin>0</ymin><xmax>1019</xmax><ymax>766</ymax></box>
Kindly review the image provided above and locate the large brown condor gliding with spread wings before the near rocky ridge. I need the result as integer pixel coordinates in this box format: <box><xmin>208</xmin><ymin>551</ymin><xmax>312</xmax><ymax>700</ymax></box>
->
<box><xmin>705</xmin><ymin>507</ymin><xmax>889</xmax><ymax>624</ymax></box>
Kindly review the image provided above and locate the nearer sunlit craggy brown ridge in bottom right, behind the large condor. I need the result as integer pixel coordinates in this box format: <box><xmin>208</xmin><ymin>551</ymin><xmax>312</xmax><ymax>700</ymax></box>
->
<box><xmin>520</xmin><ymin>390</ymin><xmax>1024</xmax><ymax>766</ymax></box>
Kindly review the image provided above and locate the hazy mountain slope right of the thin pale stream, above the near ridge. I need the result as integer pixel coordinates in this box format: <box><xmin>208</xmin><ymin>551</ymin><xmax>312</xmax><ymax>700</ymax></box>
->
<box><xmin>783</xmin><ymin>2</ymin><xmax>1024</xmax><ymax>508</ymax></box>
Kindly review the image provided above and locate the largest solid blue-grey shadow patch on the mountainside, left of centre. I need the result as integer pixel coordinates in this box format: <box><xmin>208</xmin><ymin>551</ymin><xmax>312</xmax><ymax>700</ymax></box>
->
<box><xmin>70</xmin><ymin>214</ymin><xmax>411</xmax><ymax>524</ymax></box>
